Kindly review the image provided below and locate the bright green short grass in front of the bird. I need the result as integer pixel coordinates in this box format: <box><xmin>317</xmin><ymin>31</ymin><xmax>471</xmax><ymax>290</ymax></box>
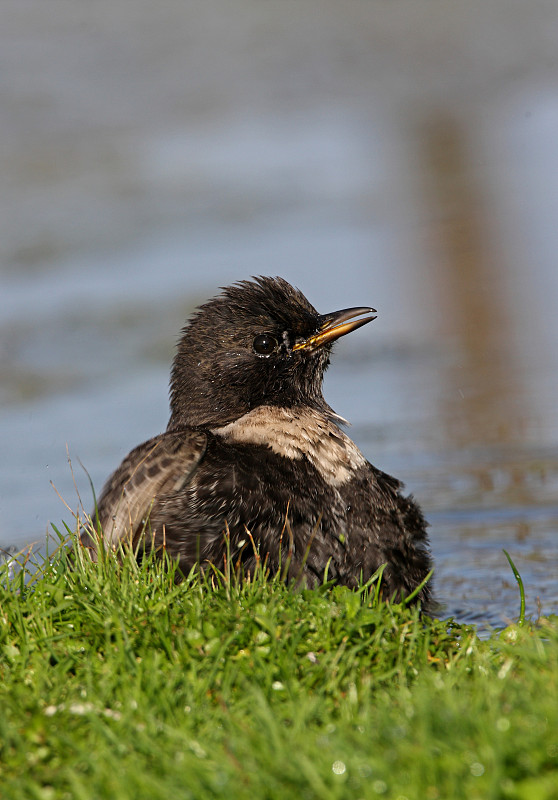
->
<box><xmin>0</xmin><ymin>528</ymin><xmax>558</xmax><ymax>800</ymax></box>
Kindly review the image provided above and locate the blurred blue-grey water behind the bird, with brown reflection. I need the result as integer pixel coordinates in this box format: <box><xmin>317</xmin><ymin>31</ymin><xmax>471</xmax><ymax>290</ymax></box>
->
<box><xmin>0</xmin><ymin>0</ymin><xmax>558</xmax><ymax>625</ymax></box>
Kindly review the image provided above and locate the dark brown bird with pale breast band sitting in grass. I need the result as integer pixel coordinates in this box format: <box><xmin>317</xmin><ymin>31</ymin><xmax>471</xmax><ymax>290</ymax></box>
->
<box><xmin>82</xmin><ymin>276</ymin><xmax>432</xmax><ymax>612</ymax></box>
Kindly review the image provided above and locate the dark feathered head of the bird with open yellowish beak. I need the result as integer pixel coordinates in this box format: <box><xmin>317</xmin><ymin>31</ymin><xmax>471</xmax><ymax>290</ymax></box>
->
<box><xmin>169</xmin><ymin>277</ymin><xmax>375</xmax><ymax>428</ymax></box>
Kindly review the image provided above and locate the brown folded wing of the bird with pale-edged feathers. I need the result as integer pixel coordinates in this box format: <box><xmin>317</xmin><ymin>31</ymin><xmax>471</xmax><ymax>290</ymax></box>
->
<box><xmin>86</xmin><ymin>429</ymin><xmax>207</xmax><ymax>547</ymax></box>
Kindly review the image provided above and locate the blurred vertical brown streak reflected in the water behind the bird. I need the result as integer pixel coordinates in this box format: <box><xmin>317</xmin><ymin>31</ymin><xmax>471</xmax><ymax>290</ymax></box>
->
<box><xmin>421</xmin><ymin>112</ymin><xmax>527</xmax><ymax>454</ymax></box>
